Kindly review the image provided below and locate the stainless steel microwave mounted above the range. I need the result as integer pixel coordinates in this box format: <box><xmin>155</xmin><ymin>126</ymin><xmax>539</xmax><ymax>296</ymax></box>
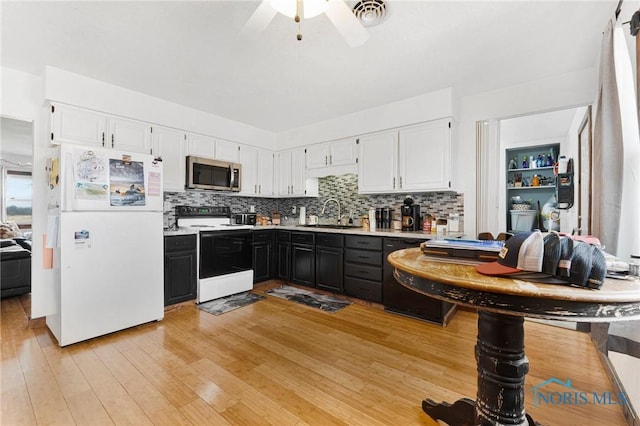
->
<box><xmin>186</xmin><ymin>155</ymin><xmax>242</xmax><ymax>192</ymax></box>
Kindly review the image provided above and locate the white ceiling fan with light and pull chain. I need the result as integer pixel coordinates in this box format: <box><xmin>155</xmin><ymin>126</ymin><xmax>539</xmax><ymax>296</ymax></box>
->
<box><xmin>241</xmin><ymin>0</ymin><xmax>369</xmax><ymax>47</ymax></box>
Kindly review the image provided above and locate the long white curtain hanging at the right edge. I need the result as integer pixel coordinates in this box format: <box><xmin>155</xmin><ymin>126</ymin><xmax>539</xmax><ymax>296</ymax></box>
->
<box><xmin>592</xmin><ymin>19</ymin><xmax>640</xmax><ymax>260</ymax></box>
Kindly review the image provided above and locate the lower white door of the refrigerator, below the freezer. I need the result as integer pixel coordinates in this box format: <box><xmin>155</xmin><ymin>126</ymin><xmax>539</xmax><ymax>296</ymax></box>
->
<box><xmin>59</xmin><ymin>212</ymin><xmax>164</xmax><ymax>346</ymax></box>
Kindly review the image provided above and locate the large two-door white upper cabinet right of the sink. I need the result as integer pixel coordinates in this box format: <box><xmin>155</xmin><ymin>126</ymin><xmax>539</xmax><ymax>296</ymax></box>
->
<box><xmin>358</xmin><ymin>119</ymin><xmax>451</xmax><ymax>193</ymax></box>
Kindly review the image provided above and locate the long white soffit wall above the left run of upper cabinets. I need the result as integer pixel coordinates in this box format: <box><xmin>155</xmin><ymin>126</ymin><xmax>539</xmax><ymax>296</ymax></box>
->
<box><xmin>44</xmin><ymin>67</ymin><xmax>276</xmax><ymax>149</ymax></box>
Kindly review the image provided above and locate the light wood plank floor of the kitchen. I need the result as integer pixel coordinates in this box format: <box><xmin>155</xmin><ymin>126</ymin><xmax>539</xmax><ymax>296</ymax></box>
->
<box><xmin>0</xmin><ymin>283</ymin><xmax>626</xmax><ymax>426</ymax></box>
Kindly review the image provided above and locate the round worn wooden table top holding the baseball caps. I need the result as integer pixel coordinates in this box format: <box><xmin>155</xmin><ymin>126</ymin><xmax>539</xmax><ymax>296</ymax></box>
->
<box><xmin>388</xmin><ymin>248</ymin><xmax>640</xmax><ymax>320</ymax></box>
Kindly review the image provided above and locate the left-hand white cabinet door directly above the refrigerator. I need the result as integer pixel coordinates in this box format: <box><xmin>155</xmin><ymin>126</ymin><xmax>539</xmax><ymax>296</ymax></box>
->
<box><xmin>51</xmin><ymin>104</ymin><xmax>107</xmax><ymax>147</ymax></box>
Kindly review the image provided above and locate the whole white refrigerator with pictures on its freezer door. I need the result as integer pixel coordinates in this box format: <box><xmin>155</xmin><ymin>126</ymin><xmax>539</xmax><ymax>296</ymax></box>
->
<box><xmin>46</xmin><ymin>144</ymin><xmax>164</xmax><ymax>346</ymax></box>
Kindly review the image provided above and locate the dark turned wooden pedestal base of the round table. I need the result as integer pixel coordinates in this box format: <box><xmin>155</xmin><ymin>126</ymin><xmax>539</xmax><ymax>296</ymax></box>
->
<box><xmin>422</xmin><ymin>311</ymin><xmax>536</xmax><ymax>426</ymax></box>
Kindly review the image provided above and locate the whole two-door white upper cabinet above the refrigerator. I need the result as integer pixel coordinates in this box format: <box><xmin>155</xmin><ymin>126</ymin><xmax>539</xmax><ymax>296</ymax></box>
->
<box><xmin>51</xmin><ymin>104</ymin><xmax>151</xmax><ymax>154</ymax></box>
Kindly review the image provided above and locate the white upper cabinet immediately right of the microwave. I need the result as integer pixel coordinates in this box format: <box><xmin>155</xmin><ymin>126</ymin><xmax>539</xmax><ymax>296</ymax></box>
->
<box><xmin>240</xmin><ymin>145</ymin><xmax>274</xmax><ymax>197</ymax></box>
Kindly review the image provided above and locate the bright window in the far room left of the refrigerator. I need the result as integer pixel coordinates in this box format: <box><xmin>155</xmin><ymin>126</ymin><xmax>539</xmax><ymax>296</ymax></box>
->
<box><xmin>2</xmin><ymin>170</ymin><xmax>31</xmax><ymax>228</ymax></box>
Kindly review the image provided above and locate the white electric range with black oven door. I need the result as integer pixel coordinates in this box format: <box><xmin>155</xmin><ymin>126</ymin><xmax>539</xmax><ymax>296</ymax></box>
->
<box><xmin>176</xmin><ymin>206</ymin><xmax>253</xmax><ymax>303</ymax></box>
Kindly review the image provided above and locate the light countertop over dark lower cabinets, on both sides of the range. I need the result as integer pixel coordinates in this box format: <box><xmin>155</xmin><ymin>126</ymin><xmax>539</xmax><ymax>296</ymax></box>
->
<box><xmin>164</xmin><ymin>225</ymin><xmax>463</xmax><ymax>241</ymax></box>
